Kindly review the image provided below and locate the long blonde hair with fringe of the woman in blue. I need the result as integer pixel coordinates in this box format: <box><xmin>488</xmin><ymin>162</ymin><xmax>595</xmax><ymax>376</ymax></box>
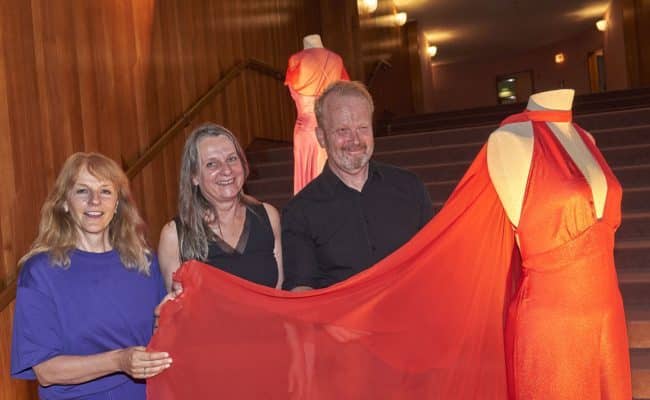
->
<box><xmin>18</xmin><ymin>153</ymin><xmax>152</xmax><ymax>275</ymax></box>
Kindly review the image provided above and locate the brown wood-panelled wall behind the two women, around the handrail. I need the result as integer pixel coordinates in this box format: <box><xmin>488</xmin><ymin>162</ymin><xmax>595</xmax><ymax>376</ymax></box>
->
<box><xmin>0</xmin><ymin>0</ymin><xmax>320</xmax><ymax>400</ymax></box>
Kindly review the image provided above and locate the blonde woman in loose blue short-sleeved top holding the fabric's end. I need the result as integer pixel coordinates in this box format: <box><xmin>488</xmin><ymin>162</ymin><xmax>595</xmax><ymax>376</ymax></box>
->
<box><xmin>11</xmin><ymin>153</ymin><xmax>172</xmax><ymax>400</ymax></box>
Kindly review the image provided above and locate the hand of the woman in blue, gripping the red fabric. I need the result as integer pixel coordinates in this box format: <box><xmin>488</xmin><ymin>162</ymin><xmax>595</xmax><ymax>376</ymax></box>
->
<box><xmin>118</xmin><ymin>346</ymin><xmax>172</xmax><ymax>379</ymax></box>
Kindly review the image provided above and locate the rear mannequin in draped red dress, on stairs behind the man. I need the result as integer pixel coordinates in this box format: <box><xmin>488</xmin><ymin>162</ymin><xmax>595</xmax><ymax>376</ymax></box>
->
<box><xmin>285</xmin><ymin>34</ymin><xmax>349</xmax><ymax>194</ymax></box>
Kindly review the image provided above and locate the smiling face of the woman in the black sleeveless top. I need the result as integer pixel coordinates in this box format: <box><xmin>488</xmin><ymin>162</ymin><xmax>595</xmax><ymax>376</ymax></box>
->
<box><xmin>192</xmin><ymin>135</ymin><xmax>245</xmax><ymax>206</ymax></box>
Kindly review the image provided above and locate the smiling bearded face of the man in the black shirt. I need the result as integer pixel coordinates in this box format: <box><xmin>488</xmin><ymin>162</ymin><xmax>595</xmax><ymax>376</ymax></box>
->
<box><xmin>316</xmin><ymin>95</ymin><xmax>374</xmax><ymax>176</ymax></box>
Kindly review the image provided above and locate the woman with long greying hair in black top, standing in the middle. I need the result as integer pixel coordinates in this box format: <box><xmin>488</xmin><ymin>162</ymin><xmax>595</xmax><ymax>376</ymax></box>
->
<box><xmin>158</xmin><ymin>123</ymin><xmax>283</xmax><ymax>290</ymax></box>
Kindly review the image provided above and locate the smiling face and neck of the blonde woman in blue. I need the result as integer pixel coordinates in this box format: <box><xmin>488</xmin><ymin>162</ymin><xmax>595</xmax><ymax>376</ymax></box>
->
<box><xmin>63</xmin><ymin>167</ymin><xmax>118</xmax><ymax>250</ymax></box>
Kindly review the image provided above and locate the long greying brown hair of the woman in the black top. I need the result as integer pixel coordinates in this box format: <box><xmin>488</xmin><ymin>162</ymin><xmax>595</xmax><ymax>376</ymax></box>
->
<box><xmin>177</xmin><ymin>123</ymin><xmax>255</xmax><ymax>261</ymax></box>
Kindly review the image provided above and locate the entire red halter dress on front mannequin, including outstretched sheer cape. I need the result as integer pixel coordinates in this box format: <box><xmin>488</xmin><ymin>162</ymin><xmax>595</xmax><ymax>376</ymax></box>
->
<box><xmin>147</xmin><ymin>113</ymin><xmax>631</xmax><ymax>400</ymax></box>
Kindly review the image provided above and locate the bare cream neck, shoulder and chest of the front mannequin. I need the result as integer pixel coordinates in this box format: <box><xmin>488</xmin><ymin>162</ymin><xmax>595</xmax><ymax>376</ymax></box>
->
<box><xmin>487</xmin><ymin>89</ymin><xmax>607</xmax><ymax>227</ymax></box>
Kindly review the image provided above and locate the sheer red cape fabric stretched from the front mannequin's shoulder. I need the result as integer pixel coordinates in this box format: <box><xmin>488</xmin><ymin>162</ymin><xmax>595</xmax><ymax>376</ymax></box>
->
<box><xmin>147</xmin><ymin>148</ymin><xmax>517</xmax><ymax>400</ymax></box>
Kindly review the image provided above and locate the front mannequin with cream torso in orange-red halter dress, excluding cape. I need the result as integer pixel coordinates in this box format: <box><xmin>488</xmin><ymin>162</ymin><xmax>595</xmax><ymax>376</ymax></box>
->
<box><xmin>487</xmin><ymin>89</ymin><xmax>632</xmax><ymax>400</ymax></box>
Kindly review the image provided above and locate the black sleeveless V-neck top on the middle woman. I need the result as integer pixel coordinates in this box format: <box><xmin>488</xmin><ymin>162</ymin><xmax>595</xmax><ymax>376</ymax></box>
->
<box><xmin>174</xmin><ymin>204</ymin><xmax>278</xmax><ymax>287</ymax></box>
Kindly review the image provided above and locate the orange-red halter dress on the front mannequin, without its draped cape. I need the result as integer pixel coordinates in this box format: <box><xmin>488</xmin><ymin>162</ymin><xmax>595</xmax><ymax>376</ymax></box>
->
<box><xmin>504</xmin><ymin>112</ymin><xmax>632</xmax><ymax>400</ymax></box>
